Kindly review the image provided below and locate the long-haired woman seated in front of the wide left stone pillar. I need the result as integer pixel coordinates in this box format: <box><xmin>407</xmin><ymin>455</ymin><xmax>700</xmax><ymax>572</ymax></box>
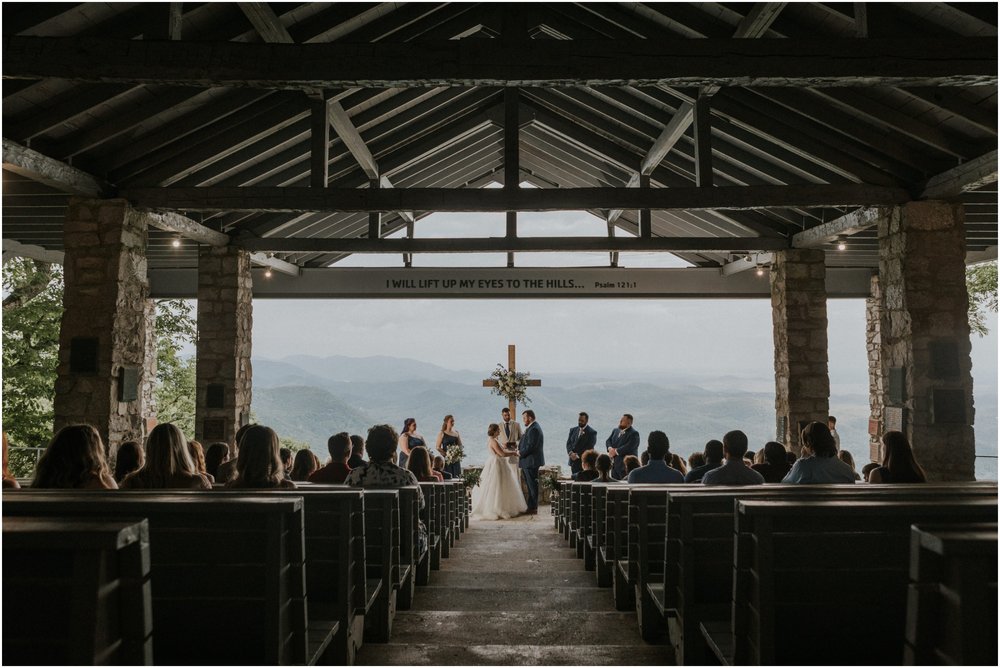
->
<box><xmin>31</xmin><ymin>424</ymin><xmax>118</xmax><ymax>489</ymax></box>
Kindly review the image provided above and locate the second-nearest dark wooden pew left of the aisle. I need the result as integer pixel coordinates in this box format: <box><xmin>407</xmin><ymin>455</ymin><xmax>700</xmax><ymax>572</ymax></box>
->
<box><xmin>3</xmin><ymin>490</ymin><xmax>310</xmax><ymax>665</ymax></box>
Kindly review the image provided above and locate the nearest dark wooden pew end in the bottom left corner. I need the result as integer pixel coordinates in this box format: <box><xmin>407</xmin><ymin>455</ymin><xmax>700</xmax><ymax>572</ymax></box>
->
<box><xmin>3</xmin><ymin>517</ymin><xmax>153</xmax><ymax>666</ymax></box>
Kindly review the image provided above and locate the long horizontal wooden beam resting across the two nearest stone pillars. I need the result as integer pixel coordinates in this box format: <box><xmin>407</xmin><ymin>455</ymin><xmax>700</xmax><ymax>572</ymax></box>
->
<box><xmin>121</xmin><ymin>184</ymin><xmax>910</xmax><ymax>212</ymax></box>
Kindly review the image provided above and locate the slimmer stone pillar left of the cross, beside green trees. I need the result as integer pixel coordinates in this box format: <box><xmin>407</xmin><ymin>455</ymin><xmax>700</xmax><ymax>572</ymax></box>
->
<box><xmin>195</xmin><ymin>246</ymin><xmax>253</xmax><ymax>445</ymax></box>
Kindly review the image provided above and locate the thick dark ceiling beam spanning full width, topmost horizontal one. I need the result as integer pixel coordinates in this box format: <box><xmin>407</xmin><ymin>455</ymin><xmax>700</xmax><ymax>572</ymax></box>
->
<box><xmin>3</xmin><ymin>36</ymin><xmax>997</xmax><ymax>90</ymax></box>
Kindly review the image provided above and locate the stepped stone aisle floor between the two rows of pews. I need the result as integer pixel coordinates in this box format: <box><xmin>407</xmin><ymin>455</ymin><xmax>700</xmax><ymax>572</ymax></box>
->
<box><xmin>357</xmin><ymin>507</ymin><xmax>674</xmax><ymax>666</ymax></box>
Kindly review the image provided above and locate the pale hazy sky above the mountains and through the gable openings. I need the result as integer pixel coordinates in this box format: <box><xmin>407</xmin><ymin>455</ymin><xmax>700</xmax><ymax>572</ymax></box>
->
<box><xmin>253</xmin><ymin>212</ymin><xmax>997</xmax><ymax>392</ymax></box>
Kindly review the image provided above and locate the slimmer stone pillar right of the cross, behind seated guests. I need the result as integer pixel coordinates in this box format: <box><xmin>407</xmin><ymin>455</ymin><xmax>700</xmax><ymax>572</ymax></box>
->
<box><xmin>771</xmin><ymin>249</ymin><xmax>830</xmax><ymax>453</ymax></box>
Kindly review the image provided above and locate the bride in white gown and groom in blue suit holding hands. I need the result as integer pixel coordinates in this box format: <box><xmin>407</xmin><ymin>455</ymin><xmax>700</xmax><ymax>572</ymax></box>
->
<box><xmin>472</xmin><ymin>408</ymin><xmax>545</xmax><ymax>520</ymax></box>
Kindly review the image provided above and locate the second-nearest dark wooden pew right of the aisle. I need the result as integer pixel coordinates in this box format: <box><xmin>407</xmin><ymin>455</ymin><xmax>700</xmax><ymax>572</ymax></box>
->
<box><xmin>732</xmin><ymin>498</ymin><xmax>997</xmax><ymax>665</ymax></box>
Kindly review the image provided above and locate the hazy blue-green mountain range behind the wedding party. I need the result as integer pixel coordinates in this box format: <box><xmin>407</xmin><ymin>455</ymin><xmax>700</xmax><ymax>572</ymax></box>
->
<box><xmin>253</xmin><ymin>355</ymin><xmax>997</xmax><ymax>479</ymax></box>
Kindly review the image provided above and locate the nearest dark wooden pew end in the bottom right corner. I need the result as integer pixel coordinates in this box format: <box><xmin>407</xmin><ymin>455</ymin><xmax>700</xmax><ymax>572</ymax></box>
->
<box><xmin>904</xmin><ymin>522</ymin><xmax>997</xmax><ymax>666</ymax></box>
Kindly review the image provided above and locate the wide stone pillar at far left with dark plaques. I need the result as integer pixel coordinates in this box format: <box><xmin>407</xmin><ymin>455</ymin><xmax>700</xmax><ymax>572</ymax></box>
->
<box><xmin>54</xmin><ymin>197</ymin><xmax>149</xmax><ymax>453</ymax></box>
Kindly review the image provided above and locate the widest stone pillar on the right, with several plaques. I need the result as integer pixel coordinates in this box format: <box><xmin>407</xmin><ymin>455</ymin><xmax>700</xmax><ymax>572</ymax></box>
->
<box><xmin>878</xmin><ymin>201</ymin><xmax>976</xmax><ymax>480</ymax></box>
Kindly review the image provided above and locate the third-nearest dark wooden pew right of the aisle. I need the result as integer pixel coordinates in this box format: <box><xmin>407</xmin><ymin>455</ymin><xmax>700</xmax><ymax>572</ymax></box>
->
<box><xmin>660</xmin><ymin>485</ymin><xmax>996</xmax><ymax>664</ymax></box>
